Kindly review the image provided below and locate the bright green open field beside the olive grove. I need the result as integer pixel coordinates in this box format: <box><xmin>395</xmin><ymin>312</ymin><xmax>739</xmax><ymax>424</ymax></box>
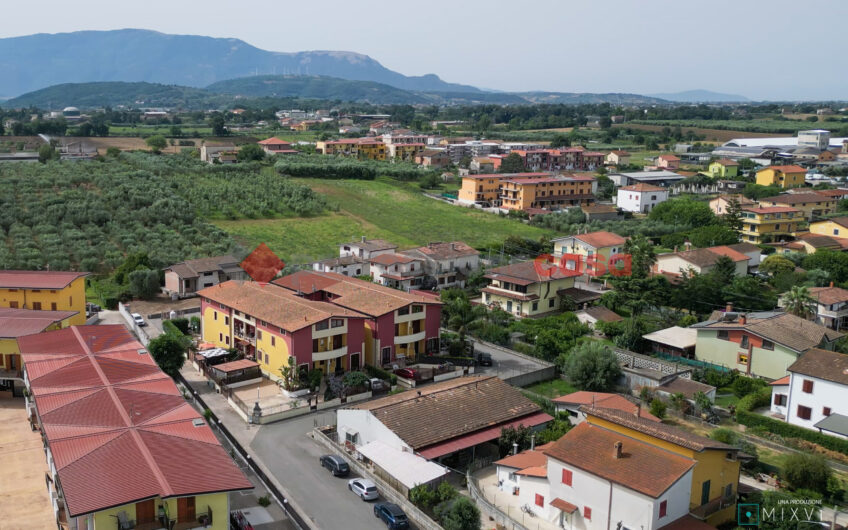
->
<box><xmin>214</xmin><ymin>178</ymin><xmax>551</xmax><ymax>263</ymax></box>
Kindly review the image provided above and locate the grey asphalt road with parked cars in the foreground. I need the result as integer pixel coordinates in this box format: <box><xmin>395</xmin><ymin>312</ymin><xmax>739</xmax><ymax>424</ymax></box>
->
<box><xmin>250</xmin><ymin>412</ymin><xmax>415</xmax><ymax>530</ymax></box>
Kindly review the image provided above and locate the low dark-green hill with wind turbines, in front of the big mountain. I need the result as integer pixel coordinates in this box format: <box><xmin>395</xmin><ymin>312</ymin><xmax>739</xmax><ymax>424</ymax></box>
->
<box><xmin>206</xmin><ymin>75</ymin><xmax>427</xmax><ymax>104</ymax></box>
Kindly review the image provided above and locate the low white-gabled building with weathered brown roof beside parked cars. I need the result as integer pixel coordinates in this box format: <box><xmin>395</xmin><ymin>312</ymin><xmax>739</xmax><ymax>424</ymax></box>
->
<box><xmin>336</xmin><ymin>375</ymin><xmax>553</xmax><ymax>461</ymax></box>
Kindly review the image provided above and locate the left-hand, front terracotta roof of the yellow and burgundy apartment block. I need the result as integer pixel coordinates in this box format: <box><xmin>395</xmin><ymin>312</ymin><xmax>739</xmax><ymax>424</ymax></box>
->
<box><xmin>197</xmin><ymin>280</ymin><xmax>365</xmax><ymax>331</ymax></box>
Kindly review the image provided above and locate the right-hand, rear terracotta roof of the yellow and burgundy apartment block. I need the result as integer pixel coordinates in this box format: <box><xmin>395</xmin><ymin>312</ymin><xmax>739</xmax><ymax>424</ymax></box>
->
<box><xmin>271</xmin><ymin>271</ymin><xmax>441</xmax><ymax>316</ymax></box>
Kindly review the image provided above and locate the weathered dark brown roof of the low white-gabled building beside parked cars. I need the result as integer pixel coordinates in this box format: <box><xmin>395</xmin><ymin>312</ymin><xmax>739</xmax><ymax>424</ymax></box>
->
<box><xmin>349</xmin><ymin>376</ymin><xmax>540</xmax><ymax>451</ymax></box>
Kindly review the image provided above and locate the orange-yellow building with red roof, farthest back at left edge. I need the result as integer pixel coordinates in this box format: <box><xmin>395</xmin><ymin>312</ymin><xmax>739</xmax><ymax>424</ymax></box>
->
<box><xmin>0</xmin><ymin>270</ymin><xmax>89</xmax><ymax>326</ymax></box>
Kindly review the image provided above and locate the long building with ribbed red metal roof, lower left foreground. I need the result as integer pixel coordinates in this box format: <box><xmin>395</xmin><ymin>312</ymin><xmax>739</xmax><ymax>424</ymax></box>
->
<box><xmin>18</xmin><ymin>325</ymin><xmax>253</xmax><ymax>530</ymax></box>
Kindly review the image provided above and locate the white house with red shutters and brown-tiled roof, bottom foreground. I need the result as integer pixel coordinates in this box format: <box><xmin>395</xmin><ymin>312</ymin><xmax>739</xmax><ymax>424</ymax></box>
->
<box><xmin>496</xmin><ymin>423</ymin><xmax>695</xmax><ymax>530</ymax></box>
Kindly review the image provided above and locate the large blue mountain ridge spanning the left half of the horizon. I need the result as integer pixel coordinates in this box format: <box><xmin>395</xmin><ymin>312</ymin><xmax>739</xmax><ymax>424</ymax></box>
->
<box><xmin>0</xmin><ymin>29</ymin><xmax>480</xmax><ymax>97</ymax></box>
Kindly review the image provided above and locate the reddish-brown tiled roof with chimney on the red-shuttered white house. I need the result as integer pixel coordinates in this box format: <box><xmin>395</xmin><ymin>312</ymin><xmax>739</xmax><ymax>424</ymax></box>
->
<box><xmin>545</xmin><ymin>422</ymin><xmax>695</xmax><ymax>499</ymax></box>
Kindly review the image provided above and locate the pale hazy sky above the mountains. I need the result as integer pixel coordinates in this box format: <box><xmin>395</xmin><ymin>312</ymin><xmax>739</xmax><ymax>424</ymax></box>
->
<box><xmin>0</xmin><ymin>0</ymin><xmax>848</xmax><ymax>99</ymax></box>
